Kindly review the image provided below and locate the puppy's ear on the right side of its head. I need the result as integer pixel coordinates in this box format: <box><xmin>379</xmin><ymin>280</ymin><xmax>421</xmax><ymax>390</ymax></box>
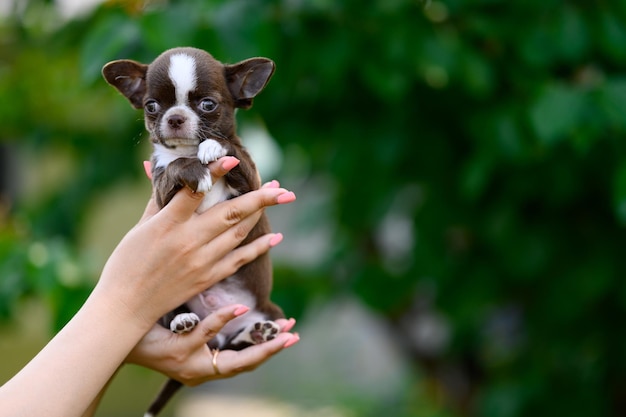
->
<box><xmin>225</xmin><ymin>58</ymin><xmax>276</xmax><ymax>109</ymax></box>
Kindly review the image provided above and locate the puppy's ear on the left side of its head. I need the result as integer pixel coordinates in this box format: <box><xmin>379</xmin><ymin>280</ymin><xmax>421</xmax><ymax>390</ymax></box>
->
<box><xmin>102</xmin><ymin>59</ymin><xmax>148</xmax><ymax>109</ymax></box>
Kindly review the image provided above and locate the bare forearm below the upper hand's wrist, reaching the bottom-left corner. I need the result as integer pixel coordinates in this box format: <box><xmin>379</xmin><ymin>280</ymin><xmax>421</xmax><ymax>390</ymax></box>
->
<box><xmin>0</xmin><ymin>295</ymin><xmax>147</xmax><ymax>417</ymax></box>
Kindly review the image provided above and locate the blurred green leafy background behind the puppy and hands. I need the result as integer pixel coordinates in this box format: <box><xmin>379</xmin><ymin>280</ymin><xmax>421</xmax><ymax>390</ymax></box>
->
<box><xmin>0</xmin><ymin>0</ymin><xmax>626</xmax><ymax>417</ymax></box>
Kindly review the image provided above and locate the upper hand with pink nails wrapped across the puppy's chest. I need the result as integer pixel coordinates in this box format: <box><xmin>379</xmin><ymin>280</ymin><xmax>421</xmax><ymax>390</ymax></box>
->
<box><xmin>94</xmin><ymin>157</ymin><xmax>295</xmax><ymax>331</ymax></box>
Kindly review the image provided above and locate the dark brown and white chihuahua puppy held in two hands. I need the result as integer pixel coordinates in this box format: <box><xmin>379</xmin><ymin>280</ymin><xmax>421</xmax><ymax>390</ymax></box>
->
<box><xmin>102</xmin><ymin>48</ymin><xmax>284</xmax><ymax>417</ymax></box>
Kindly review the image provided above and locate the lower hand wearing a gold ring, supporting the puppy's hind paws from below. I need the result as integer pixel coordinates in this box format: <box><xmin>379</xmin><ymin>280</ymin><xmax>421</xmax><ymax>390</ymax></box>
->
<box><xmin>126</xmin><ymin>305</ymin><xmax>300</xmax><ymax>386</ymax></box>
